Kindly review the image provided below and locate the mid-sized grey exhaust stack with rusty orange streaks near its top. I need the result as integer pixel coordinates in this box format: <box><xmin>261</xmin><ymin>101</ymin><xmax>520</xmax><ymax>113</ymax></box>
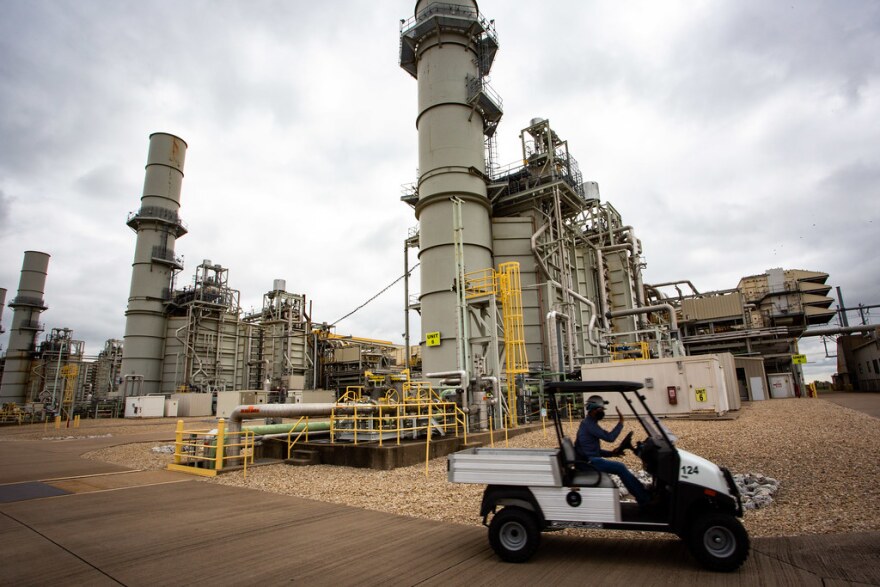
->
<box><xmin>121</xmin><ymin>133</ymin><xmax>187</xmax><ymax>395</ymax></box>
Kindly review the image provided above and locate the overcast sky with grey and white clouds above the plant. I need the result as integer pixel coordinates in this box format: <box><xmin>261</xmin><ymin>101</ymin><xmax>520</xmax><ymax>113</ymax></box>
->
<box><xmin>0</xmin><ymin>0</ymin><xmax>880</xmax><ymax>380</ymax></box>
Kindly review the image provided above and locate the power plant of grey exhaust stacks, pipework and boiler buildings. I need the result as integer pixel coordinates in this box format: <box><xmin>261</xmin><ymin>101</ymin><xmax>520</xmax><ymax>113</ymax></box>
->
<box><xmin>0</xmin><ymin>0</ymin><xmax>878</xmax><ymax>439</ymax></box>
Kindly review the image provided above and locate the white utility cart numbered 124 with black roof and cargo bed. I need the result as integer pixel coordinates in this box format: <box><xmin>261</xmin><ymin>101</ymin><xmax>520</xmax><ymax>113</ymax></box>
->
<box><xmin>448</xmin><ymin>381</ymin><xmax>749</xmax><ymax>571</ymax></box>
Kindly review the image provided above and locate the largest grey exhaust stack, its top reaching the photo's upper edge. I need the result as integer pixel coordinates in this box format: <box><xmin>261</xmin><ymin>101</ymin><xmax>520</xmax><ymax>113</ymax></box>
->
<box><xmin>400</xmin><ymin>0</ymin><xmax>501</xmax><ymax>373</ymax></box>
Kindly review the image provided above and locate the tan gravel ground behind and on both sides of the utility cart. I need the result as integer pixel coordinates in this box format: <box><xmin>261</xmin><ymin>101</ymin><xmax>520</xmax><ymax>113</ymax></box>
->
<box><xmin>62</xmin><ymin>399</ymin><xmax>880</xmax><ymax>538</ymax></box>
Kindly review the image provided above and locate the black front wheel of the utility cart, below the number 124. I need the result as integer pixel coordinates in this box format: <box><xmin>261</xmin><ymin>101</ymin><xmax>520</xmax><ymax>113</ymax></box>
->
<box><xmin>687</xmin><ymin>513</ymin><xmax>749</xmax><ymax>573</ymax></box>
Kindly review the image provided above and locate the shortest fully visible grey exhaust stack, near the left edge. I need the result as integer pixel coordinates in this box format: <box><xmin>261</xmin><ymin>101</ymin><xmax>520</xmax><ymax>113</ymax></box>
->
<box><xmin>0</xmin><ymin>251</ymin><xmax>49</xmax><ymax>404</ymax></box>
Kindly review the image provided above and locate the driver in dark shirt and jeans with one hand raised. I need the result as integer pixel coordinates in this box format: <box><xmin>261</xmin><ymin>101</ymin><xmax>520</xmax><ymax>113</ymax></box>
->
<box><xmin>574</xmin><ymin>395</ymin><xmax>651</xmax><ymax>507</ymax></box>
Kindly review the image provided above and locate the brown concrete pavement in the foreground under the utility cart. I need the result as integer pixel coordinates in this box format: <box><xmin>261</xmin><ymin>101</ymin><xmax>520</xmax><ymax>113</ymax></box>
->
<box><xmin>0</xmin><ymin>400</ymin><xmax>880</xmax><ymax>587</ymax></box>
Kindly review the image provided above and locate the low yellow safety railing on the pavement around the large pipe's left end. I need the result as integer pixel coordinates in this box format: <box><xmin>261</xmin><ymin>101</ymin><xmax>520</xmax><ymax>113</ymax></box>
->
<box><xmin>167</xmin><ymin>418</ymin><xmax>254</xmax><ymax>477</ymax></box>
